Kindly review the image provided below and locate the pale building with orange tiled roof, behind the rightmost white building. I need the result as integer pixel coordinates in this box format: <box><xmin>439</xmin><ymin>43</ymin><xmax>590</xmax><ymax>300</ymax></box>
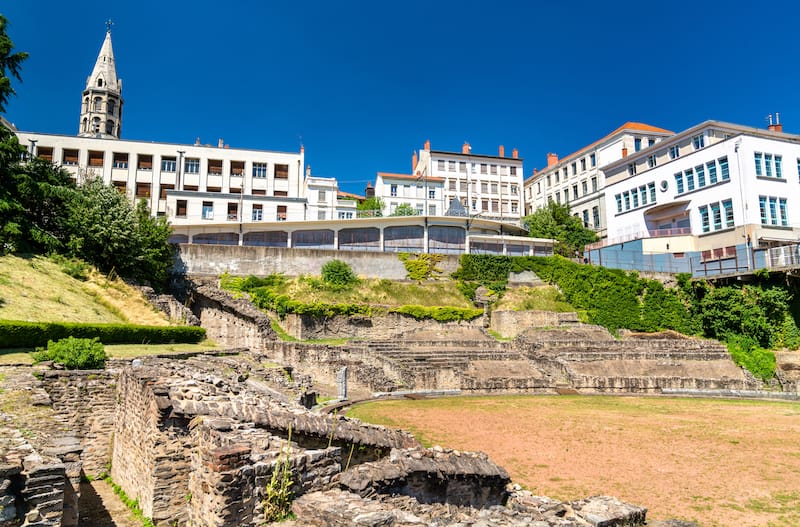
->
<box><xmin>524</xmin><ymin>122</ymin><xmax>673</xmax><ymax>237</ymax></box>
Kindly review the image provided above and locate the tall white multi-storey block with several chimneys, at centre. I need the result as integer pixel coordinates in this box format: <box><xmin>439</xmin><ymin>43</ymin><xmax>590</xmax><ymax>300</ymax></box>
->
<box><xmin>412</xmin><ymin>141</ymin><xmax>523</xmax><ymax>224</ymax></box>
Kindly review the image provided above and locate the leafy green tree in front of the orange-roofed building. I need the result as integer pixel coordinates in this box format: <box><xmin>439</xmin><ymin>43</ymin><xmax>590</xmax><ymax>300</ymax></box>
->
<box><xmin>522</xmin><ymin>200</ymin><xmax>597</xmax><ymax>258</ymax></box>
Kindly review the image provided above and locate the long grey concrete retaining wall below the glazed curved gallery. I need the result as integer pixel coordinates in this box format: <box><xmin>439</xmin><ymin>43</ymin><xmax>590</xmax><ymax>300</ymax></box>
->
<box><xmin>175</xmin><ymin>244</ymin><xmax>459</xmax><ymax>280</ymax></box>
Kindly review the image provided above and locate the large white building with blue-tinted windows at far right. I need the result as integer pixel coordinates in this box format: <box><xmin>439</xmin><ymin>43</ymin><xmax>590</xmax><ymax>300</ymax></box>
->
<box><xmin>603</xmin><ymin>117</ymin><xmax>800</xmax><ymax>262</ymax></box>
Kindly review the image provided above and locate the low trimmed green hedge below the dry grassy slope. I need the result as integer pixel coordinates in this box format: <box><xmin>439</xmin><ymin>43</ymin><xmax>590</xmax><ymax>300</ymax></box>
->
<box><xmin>0</xmin><ymin>320</ymin><xmax>206</xmax><ymax>348</ymax></box>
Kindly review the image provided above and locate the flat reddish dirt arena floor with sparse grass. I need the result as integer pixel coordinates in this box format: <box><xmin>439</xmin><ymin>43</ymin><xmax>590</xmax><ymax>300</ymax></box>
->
<box><xmin>348</xmin><ymin>396</ymin><xmax>800</xmax><ymax>527</ymax></box>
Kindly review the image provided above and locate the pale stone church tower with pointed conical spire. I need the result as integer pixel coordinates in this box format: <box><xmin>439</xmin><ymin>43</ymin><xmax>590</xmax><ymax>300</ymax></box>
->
<box><xmin>78</xmin><ymin>20</ymin><xmax>123</xmax><ymax>139</ymax></box>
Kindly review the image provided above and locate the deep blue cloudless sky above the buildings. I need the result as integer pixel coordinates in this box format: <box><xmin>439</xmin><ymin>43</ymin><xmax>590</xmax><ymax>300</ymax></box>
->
<box><xmin>0</xmin><ymin>0</ymin><xmax>800</xmax><ymax>193</ymax></box>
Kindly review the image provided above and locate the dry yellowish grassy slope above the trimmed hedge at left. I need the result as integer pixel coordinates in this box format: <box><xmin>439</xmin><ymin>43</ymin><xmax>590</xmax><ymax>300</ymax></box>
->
<box><xmin>0</xmin><ymin>256</ymin><xmax>169</xmax><ymax>326</ymax></box>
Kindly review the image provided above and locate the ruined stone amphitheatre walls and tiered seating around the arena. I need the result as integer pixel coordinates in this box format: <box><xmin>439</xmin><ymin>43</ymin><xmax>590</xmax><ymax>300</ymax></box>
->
<box><xmin>0</xmin><ymin>248</ymin><xmax>800</xmax><ymax>527</ymax></box>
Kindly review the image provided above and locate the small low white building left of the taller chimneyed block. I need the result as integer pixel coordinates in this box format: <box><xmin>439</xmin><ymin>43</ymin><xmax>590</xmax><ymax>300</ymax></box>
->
<box><xmin>375</xmin><ymin>172</ymin><xmax>447</xmax><ymax>216</ymax></box>
